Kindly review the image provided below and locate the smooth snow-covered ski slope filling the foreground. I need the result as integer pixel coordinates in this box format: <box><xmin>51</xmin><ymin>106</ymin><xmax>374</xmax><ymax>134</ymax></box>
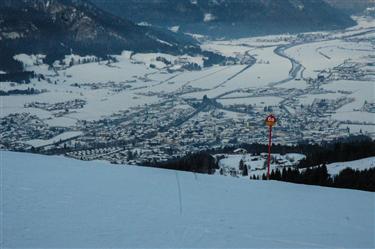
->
<box><xmin>1</xmin><ymin>152</ymin><xmax>375</xmax><ymax>248</ymax></box>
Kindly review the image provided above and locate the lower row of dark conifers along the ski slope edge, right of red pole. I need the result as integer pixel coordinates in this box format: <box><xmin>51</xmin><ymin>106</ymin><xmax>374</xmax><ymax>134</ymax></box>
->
<box><xmin>250</xmin><ymin>165</ymin><xmax>375</xmax><ymax>192</ymax></box>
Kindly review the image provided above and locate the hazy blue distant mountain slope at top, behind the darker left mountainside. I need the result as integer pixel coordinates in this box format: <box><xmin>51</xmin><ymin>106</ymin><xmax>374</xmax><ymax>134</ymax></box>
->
<box><xmin>92</xmin><ymin>0</ymin><xmax>355</xmax><ymax>36</ymax></box>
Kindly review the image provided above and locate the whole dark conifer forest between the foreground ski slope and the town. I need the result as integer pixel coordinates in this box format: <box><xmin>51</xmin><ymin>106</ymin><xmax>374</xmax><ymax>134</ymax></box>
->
<box><xmin>148</xmin><ymin>136</ymin><xmax>375</xmax><ymax>191</ymax></box>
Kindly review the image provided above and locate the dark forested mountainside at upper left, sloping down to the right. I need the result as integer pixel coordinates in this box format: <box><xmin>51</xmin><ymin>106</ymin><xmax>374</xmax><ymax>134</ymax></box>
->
<box><xmin>0</xmin><ymin>0</ymin><xmax>197</xmax><ymax>70</ymax></box>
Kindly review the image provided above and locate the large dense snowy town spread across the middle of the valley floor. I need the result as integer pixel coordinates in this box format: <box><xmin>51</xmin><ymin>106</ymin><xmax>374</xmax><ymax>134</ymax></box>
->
<box><xmin>0</xmin><ymin>82</ymin><xmax>354</xmax><ymax>164</ymax></box>
